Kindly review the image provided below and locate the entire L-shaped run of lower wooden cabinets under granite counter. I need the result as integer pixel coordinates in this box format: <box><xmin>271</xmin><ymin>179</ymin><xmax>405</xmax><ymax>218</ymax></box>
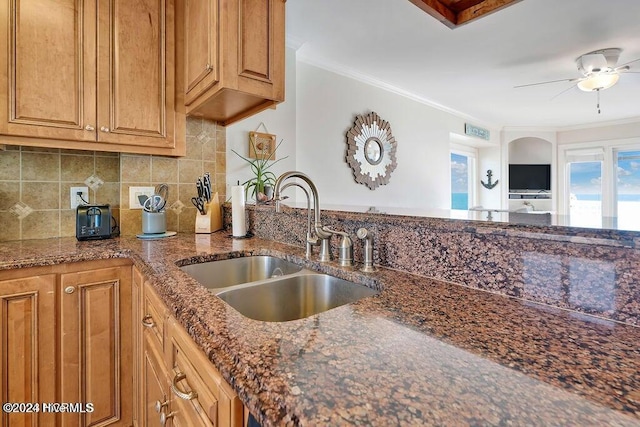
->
<box><xmin>0</xmin><ymin>259</ymin><xmax>249</xmax><ymax>427</ymax></box>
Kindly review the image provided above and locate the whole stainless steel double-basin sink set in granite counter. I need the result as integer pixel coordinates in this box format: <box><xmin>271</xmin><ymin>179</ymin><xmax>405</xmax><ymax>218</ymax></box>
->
<box><xmin>180</xmin><ymin>256</ymin><xmax>378</xmax><ymax>322</ymax></box>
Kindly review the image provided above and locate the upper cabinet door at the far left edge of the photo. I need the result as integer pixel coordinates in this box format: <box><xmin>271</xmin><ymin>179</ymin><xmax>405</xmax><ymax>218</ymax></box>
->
<box><xmin>0</xmin><ymin>0</ymin><xmax>96</xmax><ymax>141</ymax></box>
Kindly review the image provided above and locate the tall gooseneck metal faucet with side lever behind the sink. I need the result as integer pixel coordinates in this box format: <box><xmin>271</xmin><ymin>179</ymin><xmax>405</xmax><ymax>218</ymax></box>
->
<box><xmin>273</xmin><ymin>171</ymin><xmax>353</xmax><ymax>266</ymax></box>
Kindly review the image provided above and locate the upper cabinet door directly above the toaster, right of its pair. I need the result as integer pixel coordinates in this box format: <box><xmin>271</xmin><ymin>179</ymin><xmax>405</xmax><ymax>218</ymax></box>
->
<box><xmin>97</xmin><ymin>0</ymin><xmax>175</xmax><ymax>148</ymax></box>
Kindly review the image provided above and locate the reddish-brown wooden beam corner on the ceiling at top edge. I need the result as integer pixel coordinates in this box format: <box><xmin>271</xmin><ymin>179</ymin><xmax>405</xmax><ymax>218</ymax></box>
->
<box><xmin>409</xmin><ymin>0</ymin><xmax>522</xmax><ymax>29</ymax></box>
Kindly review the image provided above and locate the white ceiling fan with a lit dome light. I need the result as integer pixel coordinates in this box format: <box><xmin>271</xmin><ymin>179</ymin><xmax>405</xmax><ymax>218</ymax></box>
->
<box><xmin>514</xmin><ymin>48</ymin><xmax>640</xmax><ymax>114</ymax></box>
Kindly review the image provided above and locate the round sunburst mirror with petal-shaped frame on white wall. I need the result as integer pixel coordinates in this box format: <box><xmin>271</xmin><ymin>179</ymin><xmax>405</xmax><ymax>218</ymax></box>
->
<box><xmin>345</xmin><ymin>112</ymin><xmax>397</xmax><ymax>190</ymax></box>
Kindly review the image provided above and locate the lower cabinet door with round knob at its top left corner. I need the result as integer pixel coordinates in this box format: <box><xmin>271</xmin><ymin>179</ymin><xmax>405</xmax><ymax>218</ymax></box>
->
<box><xmin>59</xmin><ymin>267</ymin><xmax>133</xmax><ymax>426</ymax></box>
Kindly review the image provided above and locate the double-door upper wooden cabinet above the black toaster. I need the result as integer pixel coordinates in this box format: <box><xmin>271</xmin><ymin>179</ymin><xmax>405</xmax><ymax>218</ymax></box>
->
<box><xmin>0</xmin><ymin>0</ymin><xmax>185</xmax><ymax>156</ymax></box>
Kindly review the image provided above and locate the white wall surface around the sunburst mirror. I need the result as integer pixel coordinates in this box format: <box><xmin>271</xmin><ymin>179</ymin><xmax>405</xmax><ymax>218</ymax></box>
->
<box><xmin>296</xmin><ymin>62</ymin><xmax>500</xmax><ymax>209</ymax></box>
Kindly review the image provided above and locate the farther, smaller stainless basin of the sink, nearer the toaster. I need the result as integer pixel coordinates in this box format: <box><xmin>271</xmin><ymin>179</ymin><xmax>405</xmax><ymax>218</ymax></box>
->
<box><xmin>180</xmin><ymin>255</ymin><xmax>302</xmax><ymax>289</ymax></box>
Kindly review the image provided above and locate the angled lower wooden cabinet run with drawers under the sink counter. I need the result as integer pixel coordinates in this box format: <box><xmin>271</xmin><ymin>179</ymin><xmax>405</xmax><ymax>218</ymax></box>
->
<box><xmin>139</xmin><ymin>284</ymin><xmax>249</xmax><ymax>427</ymax></box>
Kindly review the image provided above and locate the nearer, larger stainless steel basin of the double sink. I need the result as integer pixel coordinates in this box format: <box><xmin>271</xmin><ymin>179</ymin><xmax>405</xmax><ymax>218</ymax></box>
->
<box><xmin>217</xmin><ymin>274</ymin><xmax>378</xmax><ymax>322</ymax></box>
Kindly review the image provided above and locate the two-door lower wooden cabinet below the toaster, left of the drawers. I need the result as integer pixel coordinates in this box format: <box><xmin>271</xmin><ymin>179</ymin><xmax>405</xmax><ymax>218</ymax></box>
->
<box><xmin>0</xmin><ymin>260</ymin><xmax>133</xmax><ymax>427</ymax></box>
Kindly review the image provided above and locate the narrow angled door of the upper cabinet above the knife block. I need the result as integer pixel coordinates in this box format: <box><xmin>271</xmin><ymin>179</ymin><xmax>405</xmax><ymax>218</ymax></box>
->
<box><xmin>181</xmin><ymin>0</ymin><xmax>220</xmax><ymax>105</ymax></box>
